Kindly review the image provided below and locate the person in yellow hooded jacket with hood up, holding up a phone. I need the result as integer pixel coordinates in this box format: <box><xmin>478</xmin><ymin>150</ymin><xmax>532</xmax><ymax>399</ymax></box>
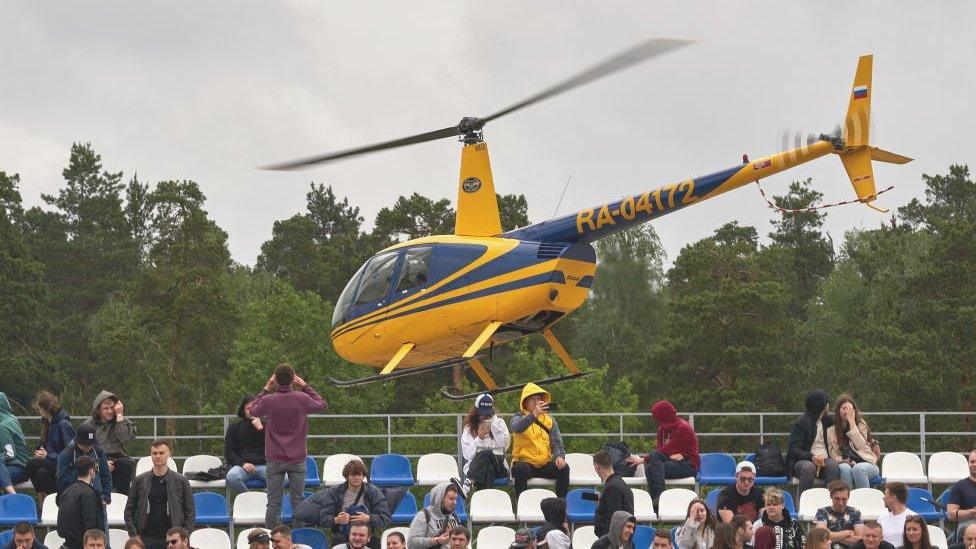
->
<box><xmin>509</xmin><ymin>383</ymin><xmax>569</xmax><ymax>498</ymax></box>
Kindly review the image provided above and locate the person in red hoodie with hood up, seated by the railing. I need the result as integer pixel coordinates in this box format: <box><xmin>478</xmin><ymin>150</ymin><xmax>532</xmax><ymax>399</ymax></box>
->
<box><xmin>627</xmin><ymin>400</ymin><xmax>701</xmax><ymax>508</ymax></box>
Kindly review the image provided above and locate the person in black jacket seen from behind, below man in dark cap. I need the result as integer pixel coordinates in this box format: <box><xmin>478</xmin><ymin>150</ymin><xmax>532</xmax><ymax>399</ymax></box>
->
<box><xmin>58</xmin><ymin>456</ymin><xmax>105</xmax><ymax>549</ymax></box>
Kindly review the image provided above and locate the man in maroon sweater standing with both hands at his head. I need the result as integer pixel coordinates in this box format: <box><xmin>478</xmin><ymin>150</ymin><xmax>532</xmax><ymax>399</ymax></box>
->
<box><xmin>251</xmin><ymin>364</ymin><xmax>325</xmax><ymax>528</ymax></box>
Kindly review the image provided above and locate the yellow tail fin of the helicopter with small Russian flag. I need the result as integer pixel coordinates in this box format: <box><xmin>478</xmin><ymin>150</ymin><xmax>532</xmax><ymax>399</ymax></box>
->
<box><xmin>838</xmin><ymin>55</ymin><xmax>912</xmax><ymax>212</ymax></box>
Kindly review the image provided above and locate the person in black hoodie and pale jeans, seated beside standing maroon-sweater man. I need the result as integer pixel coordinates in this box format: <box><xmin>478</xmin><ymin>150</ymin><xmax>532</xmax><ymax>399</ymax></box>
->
<box><xmin>224</xmin><ymin>396</ymin><xmax>266</xmax><ymax>498</ymax></box>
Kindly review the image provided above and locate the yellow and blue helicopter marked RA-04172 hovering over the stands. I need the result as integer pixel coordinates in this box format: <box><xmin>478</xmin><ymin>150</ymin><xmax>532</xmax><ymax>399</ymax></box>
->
<box><xmin>266</xmin><ymin>38</ymin><xmax>912</xmax><ymax>400</ymax></box>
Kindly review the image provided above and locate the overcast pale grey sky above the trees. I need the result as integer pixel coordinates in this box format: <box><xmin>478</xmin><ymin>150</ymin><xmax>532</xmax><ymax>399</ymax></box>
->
<box><xmin>0</xmin><ymin>0</ymin><xmax>976</xmax><ymax>265</ymax></box>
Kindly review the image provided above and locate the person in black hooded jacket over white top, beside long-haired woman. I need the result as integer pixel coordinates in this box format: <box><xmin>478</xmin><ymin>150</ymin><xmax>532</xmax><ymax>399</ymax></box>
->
<box><xmin>786</xmin><ymin>389</ymin><xmax>840</xmax><ymax>495</ymax></box>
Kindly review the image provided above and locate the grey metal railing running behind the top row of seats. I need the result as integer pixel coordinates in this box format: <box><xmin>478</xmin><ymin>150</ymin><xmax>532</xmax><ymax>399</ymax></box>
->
<box><xmin>20</xmin><ymin>412</ymin><xmax>976</xmax><ymax>463</ymax></box>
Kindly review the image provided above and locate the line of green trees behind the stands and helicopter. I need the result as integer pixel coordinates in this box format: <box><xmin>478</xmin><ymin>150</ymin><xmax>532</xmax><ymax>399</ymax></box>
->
<box><xmin>0</xmin><ymin>144</ymin><xmax>976</xmax><ymax>453</ymax></box>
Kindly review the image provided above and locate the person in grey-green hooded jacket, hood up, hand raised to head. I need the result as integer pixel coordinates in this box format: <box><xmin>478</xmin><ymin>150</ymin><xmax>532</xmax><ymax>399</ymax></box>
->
<box><xmin>83</xmin><ymin>391</ymin><xmax>136</xmax><ymax>494</ymax></box>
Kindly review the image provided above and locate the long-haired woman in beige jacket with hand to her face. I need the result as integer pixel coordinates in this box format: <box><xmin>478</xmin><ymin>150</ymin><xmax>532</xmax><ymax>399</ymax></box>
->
<box><xmin>827</xmin><ymin>395</ymin><xmax>881</xmax><ymax>490</ymax></box>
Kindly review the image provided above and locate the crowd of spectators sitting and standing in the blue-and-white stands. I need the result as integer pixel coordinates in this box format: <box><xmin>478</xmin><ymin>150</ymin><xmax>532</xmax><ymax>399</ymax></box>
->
<box><xmin>0</xmin><ymin>382</ymin><xmax>976</xmax><ymax>549</ymax></box>
